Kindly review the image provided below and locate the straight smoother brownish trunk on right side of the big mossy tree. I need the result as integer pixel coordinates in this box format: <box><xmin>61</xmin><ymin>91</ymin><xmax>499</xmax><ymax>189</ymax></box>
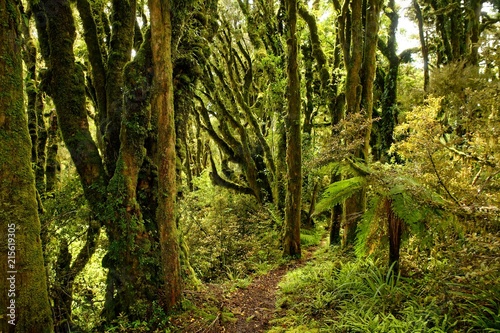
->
<box><xmin>148</xmin><ymin>0</ymin><xmax>182</xmax><ymax>311</ymax></box>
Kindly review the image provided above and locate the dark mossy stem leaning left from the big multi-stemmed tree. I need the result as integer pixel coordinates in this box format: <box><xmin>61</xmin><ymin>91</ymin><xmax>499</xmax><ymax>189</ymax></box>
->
<box><xmin>38</xmin><ymin>0</ymin><xmax>106</xmax><ymax>208</ymax></box>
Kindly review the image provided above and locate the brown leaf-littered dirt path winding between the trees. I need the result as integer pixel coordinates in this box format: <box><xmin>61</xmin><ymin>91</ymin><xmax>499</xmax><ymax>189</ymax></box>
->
<box><xmin>172</xmin><ymin>239</ymin><xmax>326</xmax><ymax>333</ymax></box>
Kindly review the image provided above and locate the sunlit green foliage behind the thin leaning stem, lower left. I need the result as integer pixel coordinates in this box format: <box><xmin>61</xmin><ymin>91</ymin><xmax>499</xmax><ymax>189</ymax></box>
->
<box><xmin>40</xmin><ymin>177</ymin><xmax>106</xmax><ymax>332</ymax></box>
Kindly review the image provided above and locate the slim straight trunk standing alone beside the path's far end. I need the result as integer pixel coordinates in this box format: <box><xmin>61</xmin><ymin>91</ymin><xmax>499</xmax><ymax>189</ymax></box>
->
<box><xmin>283</xmin><ymin>0</ymin><xmax>302</xmax><ymax>257</ymax></box>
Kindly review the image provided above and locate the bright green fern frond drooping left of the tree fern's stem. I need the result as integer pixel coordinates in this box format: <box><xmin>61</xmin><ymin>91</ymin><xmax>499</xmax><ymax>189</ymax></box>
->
<box><xmin>314</xmin><ymin>177</ymin><xmax>366</xmax><ymax>214</ymax></box>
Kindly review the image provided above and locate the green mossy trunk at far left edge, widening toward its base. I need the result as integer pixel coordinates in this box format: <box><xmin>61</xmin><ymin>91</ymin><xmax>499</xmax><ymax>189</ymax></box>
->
<box><xmin>0</xmin><ymin>0</ymin><xmax>53</xmax><ymax>333</ymax></box>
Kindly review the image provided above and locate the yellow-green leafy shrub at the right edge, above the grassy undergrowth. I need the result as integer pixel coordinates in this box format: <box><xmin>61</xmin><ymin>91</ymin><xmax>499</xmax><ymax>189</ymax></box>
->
<box><xmin>392</xmin><ymin>63</ymin><xmax>500</xmax><ymax>228</ymax></box>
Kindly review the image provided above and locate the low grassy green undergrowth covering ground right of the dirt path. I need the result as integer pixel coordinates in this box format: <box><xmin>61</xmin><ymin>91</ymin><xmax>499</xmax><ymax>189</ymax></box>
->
<box><xmin>269</xmin><ymin>233</ymin><xmax>500</xmax><ymax>333</ymax></box>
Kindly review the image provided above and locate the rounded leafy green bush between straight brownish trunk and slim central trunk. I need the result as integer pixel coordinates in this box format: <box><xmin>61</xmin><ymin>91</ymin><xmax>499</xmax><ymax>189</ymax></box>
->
<box><xmin>179</xmin><ymin>172</ymin><xmax>281</xmax><ymax>281</ymax></box>
